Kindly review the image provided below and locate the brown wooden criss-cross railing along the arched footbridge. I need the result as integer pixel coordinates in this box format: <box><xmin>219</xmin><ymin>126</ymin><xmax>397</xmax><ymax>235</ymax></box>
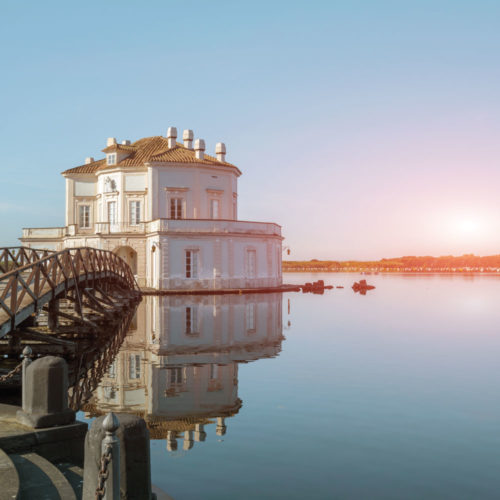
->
<box><xmin>0</xmin><ymin>247</ymin><xmax>138</xmax><ymax>337</ymax></box>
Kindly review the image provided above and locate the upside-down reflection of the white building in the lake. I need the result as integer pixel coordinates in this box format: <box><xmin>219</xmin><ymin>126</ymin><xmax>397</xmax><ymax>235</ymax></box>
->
<box><xmin>85</xmin><ymin>294</ymin><xmax>283</xmax><ymax>450</ymax></box>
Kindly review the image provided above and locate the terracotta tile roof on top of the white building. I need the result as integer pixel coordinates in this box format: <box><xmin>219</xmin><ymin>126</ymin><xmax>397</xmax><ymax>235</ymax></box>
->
<box><xmin>63</xmin><ymin>136</ymin><xmax>239</xmax><ymax>174</ymax></box>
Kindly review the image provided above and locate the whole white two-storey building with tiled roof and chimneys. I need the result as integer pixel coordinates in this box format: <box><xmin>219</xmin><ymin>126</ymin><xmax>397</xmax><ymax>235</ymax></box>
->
<box><xmin>20</xmin><ymin>127</ymin><xmax>282</xmax><ymax>289</ymax></box>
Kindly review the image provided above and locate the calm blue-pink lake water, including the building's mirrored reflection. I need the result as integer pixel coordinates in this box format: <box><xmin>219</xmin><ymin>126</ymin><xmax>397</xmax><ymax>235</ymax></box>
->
<box><xmin>81</xmin><ymin>274</ymin><xmax>500</xmax><ymax>500</ymax></box>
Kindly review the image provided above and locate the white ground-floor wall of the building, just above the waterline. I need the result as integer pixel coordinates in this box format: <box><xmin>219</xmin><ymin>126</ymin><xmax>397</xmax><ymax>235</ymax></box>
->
<box><xmin>22</xmin><ymin>225</ymin><xmax>282</xmax><ymax>290</ymax></box>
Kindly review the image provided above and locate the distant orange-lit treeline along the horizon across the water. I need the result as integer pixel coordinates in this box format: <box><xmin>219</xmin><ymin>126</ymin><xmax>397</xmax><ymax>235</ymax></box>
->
<box><xmin>283</xmin><ymin>254</ymin><xmax>500</xmax><ymax>273</ymax></box>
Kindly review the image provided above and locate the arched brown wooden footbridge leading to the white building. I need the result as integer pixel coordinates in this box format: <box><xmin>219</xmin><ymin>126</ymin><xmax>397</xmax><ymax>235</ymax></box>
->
<box><xmin>0</xmin><ymin>247</ymin><xmax>137</xmax><ymax>338</ymax></box>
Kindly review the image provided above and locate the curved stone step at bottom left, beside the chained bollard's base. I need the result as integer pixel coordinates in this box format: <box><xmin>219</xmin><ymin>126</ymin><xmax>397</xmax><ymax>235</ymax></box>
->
<box><xmin>10</xmin><ymin>453</ymin><xmax>77</xmax><ymax>500</ymax></box>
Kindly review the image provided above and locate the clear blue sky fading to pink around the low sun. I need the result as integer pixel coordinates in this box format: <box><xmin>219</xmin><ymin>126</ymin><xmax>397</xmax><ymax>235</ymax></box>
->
<box><xmin>0</xmin><ymin>0</ymin><xmax>500</xmax><ymax>260</ymax></box>
